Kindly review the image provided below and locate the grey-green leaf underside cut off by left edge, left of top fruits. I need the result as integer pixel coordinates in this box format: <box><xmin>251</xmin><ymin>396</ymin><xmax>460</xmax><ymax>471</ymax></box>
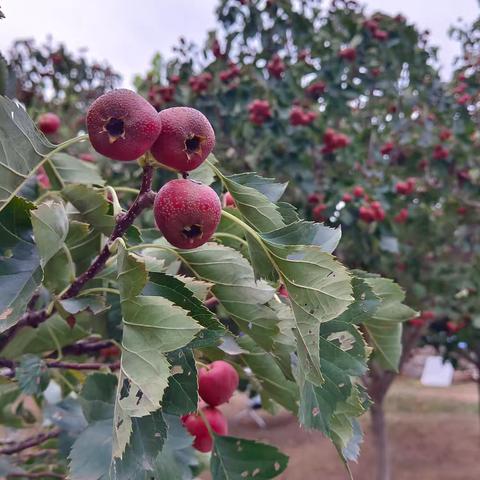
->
<box><xmin>0</xmin><ymin>96</ymin><xmax>55</xmax><ymax>210</ymax></box>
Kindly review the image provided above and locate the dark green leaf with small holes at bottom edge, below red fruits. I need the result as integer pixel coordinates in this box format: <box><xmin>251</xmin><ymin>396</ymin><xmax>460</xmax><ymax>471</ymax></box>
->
<box><xmin>210</xmin><ymin>435</ymin><xmax>288</xmax><ymax>480</ymax></box>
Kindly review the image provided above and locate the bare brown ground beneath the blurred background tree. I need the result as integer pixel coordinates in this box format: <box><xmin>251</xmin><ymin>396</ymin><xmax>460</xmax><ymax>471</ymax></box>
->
<box><xmin>202</xmin><ymin>379</ymin><xmax>480</xmax><ymax>480</ymax></box>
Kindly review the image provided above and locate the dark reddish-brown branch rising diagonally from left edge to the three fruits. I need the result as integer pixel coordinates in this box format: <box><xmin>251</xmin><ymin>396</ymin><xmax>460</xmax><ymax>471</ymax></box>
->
<box><xmin>0</xmin><ymin>165</ymin><xmax>155</xmax><ymax>351</ymax></box>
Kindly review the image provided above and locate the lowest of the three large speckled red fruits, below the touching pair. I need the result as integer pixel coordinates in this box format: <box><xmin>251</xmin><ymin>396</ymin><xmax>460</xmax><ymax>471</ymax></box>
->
<box><xmin>153</xmin><ymin>179</ymin><xmax>222</xmax><ymax>249</ymax></box>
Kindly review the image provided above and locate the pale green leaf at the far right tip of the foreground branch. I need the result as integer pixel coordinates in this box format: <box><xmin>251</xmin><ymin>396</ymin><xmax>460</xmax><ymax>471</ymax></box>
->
<box><xmin>354</xmin><ymin>271</ymin><xmax>415</xmax><ymax>372</ymax></box>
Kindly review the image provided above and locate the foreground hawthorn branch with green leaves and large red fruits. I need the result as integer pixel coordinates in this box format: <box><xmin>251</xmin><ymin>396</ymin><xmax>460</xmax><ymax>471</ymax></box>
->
<box><xmin>0</xmin><ymin>78</ymin><xmax>413</xmax><ymax>480</ymax></box>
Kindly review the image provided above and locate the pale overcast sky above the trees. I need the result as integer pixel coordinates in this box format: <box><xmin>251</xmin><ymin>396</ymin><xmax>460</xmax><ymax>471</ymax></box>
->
<box><xmin>0</xmin><ymin>0</ymin><xmax>479</xmax><ymax>86</ymax></box>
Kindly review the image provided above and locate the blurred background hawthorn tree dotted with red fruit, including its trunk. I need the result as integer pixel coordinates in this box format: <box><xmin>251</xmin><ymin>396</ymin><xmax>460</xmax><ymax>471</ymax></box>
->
<box><xmin>136</xmin><ymin>0</ymin><xmax>480</xmax><ymax>480</ymax></box>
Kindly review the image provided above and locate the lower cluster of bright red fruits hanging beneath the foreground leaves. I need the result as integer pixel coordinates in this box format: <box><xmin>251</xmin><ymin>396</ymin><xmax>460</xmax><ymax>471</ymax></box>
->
<box><xmin>182</xmin><ymin>360</ymin><xmax>239</xmax><ymax>452</ymax></box>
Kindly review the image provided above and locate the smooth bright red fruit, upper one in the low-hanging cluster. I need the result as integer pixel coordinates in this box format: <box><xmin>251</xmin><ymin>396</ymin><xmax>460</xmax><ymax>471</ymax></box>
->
<box><xmin>198</xmin><ymin>360</ymin><xmax>239</xmax><ymax>407</ymax></box>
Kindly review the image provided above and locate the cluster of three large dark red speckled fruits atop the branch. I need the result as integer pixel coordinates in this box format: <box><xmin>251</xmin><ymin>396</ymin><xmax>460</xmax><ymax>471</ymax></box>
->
<box><xmin>82</xmin><ymin>89</ymin><xmax>222</xmax><ymax>249</ymax></box>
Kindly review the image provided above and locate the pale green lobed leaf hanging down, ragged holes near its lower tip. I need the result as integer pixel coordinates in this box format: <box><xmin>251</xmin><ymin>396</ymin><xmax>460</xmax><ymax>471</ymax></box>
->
<box><xmin>113</xmin><ymin>244</ymin><xmax>202</xmax><ymax>458</ymax></box>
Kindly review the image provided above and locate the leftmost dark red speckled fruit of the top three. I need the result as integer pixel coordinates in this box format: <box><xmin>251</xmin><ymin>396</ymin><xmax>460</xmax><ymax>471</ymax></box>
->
<box><xmin>87</xmin><ymin>89</ymin><xmax>162</xmax><ymax>161</ymax></box>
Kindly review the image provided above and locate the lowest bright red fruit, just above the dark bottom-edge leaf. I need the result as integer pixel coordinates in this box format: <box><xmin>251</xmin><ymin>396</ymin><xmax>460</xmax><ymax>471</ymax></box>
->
<box><xmin>182</xmin><ymin>407</ymin><xmax>228</xmax><ymax>453</ymax></box>
